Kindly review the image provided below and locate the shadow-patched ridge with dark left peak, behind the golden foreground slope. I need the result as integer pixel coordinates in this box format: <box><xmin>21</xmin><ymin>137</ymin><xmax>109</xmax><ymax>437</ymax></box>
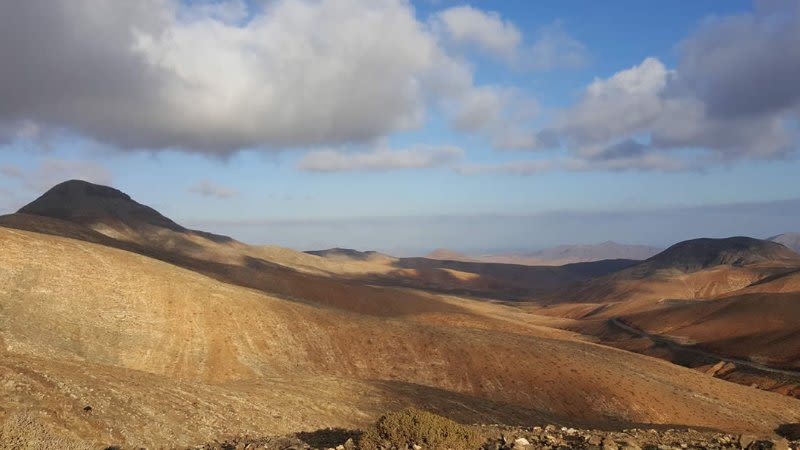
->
<box><xmin>0</xmin><ymin>180</ymin><xmax>632</xmax><ymax>302</ymax></box>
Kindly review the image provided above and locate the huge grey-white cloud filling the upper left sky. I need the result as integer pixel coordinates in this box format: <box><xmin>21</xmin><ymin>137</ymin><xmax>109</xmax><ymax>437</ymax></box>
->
<box><xmin>0</xmin><ymin>0</ymin><xmax>472</xmax><ymax>154</ymax></box>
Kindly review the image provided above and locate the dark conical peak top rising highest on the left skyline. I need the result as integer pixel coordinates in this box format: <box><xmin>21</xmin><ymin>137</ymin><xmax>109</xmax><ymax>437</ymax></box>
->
<box><xmin>17</xmin><ymin>180</ymin><xmax>185</xmax><ymax>231</ymax></box>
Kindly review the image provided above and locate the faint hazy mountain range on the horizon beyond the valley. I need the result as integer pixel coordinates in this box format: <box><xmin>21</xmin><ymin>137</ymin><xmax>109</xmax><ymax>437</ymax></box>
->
<box><xmin>426</xmin><ymin>241</ymin><xmax>663</xmax><ymax>266</ymax></box>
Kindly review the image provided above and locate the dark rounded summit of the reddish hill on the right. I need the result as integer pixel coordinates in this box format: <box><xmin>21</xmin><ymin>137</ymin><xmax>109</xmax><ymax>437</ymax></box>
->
<box><xmin>643</xmin><ymin>236</ymin><xmax>800</xmax><ymax>272</ymax></box>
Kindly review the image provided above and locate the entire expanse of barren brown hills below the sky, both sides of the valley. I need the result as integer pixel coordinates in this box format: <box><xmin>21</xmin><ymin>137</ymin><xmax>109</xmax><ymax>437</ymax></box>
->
<box><xmin>0</xmin><ymin>180</ymin><xmax>800</xmax><ymax>442</ymax></box>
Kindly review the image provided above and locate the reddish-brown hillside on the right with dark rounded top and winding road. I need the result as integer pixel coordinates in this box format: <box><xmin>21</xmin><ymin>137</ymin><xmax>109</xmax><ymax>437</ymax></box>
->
<box><xmin>526</xmin><ymin>237</ymin><xmax>800</xmax><ymax>396</ymax></box>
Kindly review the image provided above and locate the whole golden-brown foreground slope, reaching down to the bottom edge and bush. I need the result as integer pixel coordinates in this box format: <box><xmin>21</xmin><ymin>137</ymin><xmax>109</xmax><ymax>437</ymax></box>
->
<box><xmin>0</xmin><ymin>229</ymin><xmax>800</xmax><ymax>445</ymax></box>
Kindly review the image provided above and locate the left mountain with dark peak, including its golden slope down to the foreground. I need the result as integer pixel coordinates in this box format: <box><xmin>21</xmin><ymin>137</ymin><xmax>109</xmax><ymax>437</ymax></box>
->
<box><xmin>0</xmin><ymin>183</ymin><xmax>800</xmax><ymax>448</ymax></box>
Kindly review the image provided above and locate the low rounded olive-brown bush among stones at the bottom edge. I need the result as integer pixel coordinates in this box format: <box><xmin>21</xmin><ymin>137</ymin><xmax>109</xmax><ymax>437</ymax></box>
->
<box><xmin>359</xmin><ymin>408</ymin><xmax>483</xmax><ymax>450</ymax></box>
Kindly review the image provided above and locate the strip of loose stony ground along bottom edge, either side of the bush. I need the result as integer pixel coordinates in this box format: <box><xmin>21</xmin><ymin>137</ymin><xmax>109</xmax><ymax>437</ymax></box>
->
<box><xmin>189</xmin><ymin>425</ymin><xmax>800</xmax><ymax>450</ymax></box>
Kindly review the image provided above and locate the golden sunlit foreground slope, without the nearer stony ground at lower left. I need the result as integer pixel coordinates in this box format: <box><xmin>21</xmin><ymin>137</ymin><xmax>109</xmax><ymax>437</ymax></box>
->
<box><xmin>0</xmin><ymin>229</ymin><xmax>800</xmax><ymax>444</ymax></box>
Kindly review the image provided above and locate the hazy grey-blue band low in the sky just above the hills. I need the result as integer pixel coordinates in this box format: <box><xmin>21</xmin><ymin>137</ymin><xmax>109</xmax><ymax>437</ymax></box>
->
<box><xmin>179</xmin><ymin>195</ymin><xmax>800</xmax><ymax>256</ymax></box>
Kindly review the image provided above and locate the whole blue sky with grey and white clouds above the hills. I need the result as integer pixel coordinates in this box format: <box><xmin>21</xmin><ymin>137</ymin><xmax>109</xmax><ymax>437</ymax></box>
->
<box><xmin>0</xmin><ymin>0</ymin><xmax>800</xmax><ymax>255</ymax></box>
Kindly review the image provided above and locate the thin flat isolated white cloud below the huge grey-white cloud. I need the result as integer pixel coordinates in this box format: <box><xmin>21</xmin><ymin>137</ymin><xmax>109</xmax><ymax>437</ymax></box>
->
<box><xmin>297</xmin><ymin>146</ymin><xmax>464</xmax><ymax>172</ymax></box>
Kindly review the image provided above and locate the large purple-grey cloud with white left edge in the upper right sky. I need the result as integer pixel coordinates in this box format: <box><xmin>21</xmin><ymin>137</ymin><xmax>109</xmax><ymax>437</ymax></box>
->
<box><xmin>553</xmin><ymin>2</ymin><xmax>800</xmax><ymax>170</ymax></box>
